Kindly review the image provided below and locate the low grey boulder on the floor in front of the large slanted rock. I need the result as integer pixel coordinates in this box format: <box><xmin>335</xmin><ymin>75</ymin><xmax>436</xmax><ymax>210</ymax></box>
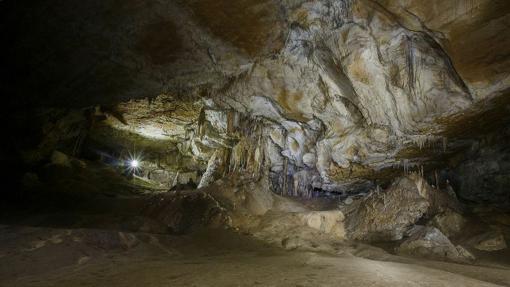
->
<box><xmin>397</xmin><ymin>226</ymin><xmax>474</xmax><ymax>262</ymax></box>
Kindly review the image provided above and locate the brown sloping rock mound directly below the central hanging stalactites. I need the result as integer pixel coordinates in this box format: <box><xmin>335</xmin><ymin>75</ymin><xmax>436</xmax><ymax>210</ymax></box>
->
<box><xmin>195</xmin><ymin>174</ymin><xmax>346</xmax><ymax>252</ymax></box>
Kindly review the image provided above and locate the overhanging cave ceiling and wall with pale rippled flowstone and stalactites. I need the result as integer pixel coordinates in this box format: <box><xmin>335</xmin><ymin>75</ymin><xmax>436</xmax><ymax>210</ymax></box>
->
<box><xmin>4</xmin><ymin>0</ymin><xmax>510</xmax><ymax>199</ymax></box>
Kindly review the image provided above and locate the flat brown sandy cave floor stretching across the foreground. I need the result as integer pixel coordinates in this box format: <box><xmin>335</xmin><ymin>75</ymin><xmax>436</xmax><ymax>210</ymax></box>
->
<box><xmin>0</xmin><ymin>225</ymin><xmax>510</xmax><ymax>287</ymax></box>
